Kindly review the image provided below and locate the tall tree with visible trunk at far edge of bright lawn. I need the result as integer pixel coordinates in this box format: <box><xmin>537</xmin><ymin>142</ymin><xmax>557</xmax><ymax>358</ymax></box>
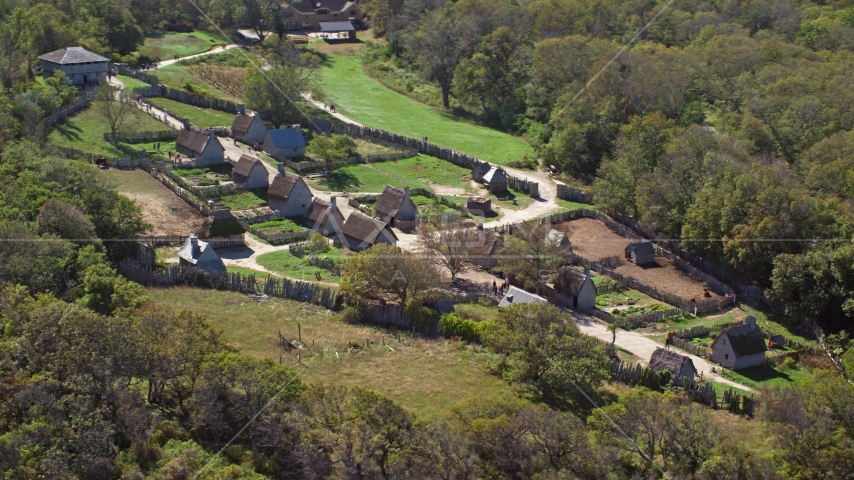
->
<box><xmin>404</xmin><ymin>6</ymin><xmax>477</xmax><ymax>108</ymax></box>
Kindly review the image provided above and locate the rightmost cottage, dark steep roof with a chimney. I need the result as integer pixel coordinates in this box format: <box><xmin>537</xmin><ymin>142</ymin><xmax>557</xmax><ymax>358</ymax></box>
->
<box><xmin>710</xmin><ymin>317</ymin><xmax>767</xmax><ymax>370</ymax></box>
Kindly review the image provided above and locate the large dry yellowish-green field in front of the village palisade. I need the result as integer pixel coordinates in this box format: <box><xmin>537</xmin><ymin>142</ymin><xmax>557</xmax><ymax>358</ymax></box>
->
<box><xmin>148</xmin><ymin>287</ymin><xmax>512</xmax><ymax>420</ymax></box>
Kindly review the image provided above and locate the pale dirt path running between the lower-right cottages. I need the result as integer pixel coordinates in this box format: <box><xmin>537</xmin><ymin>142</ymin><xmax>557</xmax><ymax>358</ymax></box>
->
<box><xmin>570</xmin><ymin>312</ymin><xmax>756</xmax><ymax>393</ymax></box>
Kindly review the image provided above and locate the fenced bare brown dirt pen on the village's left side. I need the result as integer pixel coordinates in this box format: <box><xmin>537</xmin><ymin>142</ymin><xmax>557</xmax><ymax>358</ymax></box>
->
<box><xmin>103</xmin><ymin>168</ymin><xmax>205</xmax><ymax>235</ymax></box>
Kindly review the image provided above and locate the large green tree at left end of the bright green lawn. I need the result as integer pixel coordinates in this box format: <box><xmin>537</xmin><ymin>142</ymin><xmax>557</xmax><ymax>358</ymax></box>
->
<box><xmin>243</xmin><ymin>49</ymin><xmax>318</xmax><ymax>128</ymax></box>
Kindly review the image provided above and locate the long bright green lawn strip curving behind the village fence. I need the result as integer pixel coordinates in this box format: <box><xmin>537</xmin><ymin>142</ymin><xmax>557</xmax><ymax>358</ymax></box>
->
<box><xmin>320</xmin><ymin>55</ymin><xmax>534</xmax><ymax>165</ymax></box>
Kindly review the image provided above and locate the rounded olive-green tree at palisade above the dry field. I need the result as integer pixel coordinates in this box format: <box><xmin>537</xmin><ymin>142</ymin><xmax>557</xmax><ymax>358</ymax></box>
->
<box><xmin>341</xmin><ymin>244</ymin><xmax>441</xmax><ymax>305</ymax></box>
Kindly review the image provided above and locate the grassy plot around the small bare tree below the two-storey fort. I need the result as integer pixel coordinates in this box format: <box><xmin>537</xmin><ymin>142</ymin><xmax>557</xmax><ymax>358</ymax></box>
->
<box><xmin>47</xmin><ymin>108</ymin><xmax>168</xmax><ymax>157</ymax></box>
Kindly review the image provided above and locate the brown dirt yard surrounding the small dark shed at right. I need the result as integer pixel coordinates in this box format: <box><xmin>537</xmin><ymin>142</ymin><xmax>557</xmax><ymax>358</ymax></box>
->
<box><xmin>554</xmin><ymin>218</ymin><xmax>719</xmax><ymax>301</ymax></box>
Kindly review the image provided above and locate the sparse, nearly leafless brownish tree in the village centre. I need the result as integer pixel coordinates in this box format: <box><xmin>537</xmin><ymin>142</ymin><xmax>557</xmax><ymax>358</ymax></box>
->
<box><xmin>416</xmin><ymin>221</ymin><xmax>485</xmax><ymax>283</ymax></box>
